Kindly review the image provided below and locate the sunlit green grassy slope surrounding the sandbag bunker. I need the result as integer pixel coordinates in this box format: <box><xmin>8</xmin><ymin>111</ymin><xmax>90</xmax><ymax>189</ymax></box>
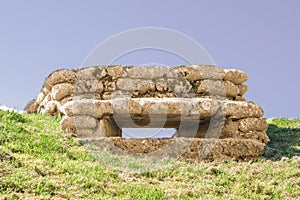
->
<box><xmin>0</xmin><ymin>111</ymin><xmax>300</xmax><ymax>199</ymax></box>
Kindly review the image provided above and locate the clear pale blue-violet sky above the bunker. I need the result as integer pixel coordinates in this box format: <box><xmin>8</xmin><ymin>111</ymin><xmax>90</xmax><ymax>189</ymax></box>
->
<box><xmin>0</xmin><ymin>0</ymin><xmax>300</xmax><ymax>118</ymax></box>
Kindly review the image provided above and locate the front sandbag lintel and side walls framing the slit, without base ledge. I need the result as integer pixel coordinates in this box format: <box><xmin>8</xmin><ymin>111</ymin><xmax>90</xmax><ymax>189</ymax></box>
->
<box><xmin>61</xmin><ymin>98</ymin><xmax>268</xmax><ymax>144</ymax></box>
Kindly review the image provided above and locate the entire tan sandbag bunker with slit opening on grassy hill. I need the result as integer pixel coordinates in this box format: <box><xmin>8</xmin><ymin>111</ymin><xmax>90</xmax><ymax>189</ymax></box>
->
<box><xmin>25</xmin><ymin>65</ymin><xmax>269</xmax><ymax>161</ymax></box>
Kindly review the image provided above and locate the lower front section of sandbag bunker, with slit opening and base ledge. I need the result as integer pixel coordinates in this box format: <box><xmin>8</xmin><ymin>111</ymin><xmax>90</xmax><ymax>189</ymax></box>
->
<box><xmin>57</xmin><ymin>98</ymin><xmax>269</xmax><ymax>162</ymax></box>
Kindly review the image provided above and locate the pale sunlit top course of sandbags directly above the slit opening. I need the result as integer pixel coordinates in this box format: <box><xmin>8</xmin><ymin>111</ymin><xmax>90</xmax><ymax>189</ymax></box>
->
<box><xmin>64</xmin><ymin>98</ymin><xmax>263</xmax><ymax>123</ymax></box>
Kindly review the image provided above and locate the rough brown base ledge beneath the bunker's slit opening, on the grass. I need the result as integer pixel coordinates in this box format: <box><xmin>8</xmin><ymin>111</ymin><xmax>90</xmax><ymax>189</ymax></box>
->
<box><xmin>90</xmin><ymin>137</ymin><xmax>265</xmax><ymax>162</ymax></box>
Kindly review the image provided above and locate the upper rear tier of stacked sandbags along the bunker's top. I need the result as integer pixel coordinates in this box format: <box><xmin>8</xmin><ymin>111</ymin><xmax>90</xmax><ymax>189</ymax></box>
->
<box><xmin>26</xmin><ymin>65</ymin><xmax>248</xmax><ymax>115</ymax></box>
